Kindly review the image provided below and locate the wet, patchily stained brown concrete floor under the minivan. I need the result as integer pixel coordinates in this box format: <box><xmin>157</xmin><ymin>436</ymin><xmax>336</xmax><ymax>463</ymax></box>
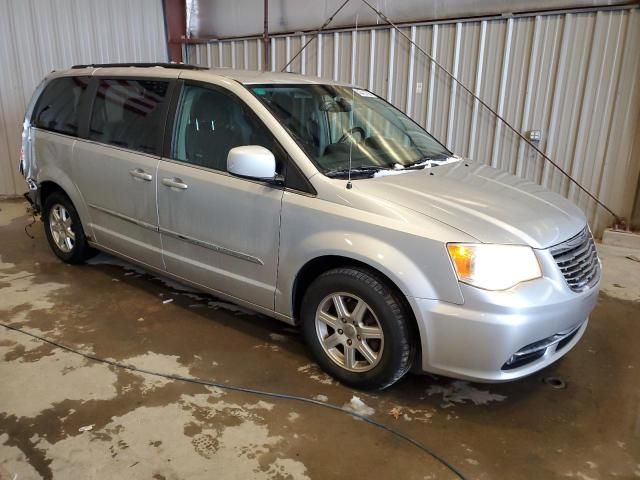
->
<box><xmin>0</xmin><ymin>197</ymin><xmax>640</xmax><ymax>480</ymax></box>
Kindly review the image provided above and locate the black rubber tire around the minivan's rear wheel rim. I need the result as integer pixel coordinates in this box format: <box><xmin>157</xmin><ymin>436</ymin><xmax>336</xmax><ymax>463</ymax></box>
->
<box><xmin>42</xmin><ymin>191</ymin><xmax>97</xmax><ymax>264</ymax></box>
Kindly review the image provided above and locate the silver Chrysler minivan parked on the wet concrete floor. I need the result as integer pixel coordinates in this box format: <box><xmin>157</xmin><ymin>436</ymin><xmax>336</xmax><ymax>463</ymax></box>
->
<box><xmin>20</xmin><ymin>64</ymin><xmax>601</xmax><ymax>388</ymax></box>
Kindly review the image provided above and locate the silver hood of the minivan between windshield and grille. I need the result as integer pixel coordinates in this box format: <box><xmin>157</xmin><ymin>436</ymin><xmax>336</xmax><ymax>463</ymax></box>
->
<box><xmin>353</xmin><ymin>160</ymin><xmax>586</xmax><ymax>248</ymax></box>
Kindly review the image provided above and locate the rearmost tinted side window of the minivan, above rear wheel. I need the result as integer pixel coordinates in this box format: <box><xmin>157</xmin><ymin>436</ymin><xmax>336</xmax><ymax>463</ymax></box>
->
<box><xmin>33</xmin><ymin>77</ymin><xmax>89</xmax><ymax>135</ymax></box>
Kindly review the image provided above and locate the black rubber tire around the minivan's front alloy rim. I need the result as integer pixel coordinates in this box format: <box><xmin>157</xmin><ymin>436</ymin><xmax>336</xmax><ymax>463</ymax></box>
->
<box><xmin>301</xmin><ymin>267</ymin><xmax>415</xmax><ymax>390</ymax></box>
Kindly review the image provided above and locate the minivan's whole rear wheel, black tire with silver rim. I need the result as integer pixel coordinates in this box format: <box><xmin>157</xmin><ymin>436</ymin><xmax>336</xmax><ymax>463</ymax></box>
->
<box><xmin>42</xmin><ymin>192</ymin><xmax>95</xmax><ymax>264</ymax></box>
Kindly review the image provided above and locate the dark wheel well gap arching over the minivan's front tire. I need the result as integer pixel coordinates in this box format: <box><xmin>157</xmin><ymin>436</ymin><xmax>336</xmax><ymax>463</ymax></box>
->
<box><xmin>293</xmin><ymin>255</ymin><xmax>421</xmax><ymax>354</ymax></box>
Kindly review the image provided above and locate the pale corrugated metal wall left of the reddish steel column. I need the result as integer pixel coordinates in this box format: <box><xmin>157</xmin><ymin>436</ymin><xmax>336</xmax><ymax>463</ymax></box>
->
<box><xmin>0</xmin><ymin>0</ymin><xmax>167</xmax><ymax>195</ymax></box>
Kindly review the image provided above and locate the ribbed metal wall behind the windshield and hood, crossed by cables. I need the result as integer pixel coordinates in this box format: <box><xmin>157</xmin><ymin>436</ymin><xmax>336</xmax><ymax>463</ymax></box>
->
<box><xmin>188</xmin><ymin>8</ymin><xmax>640</xmax><ymax>231</ymax></box>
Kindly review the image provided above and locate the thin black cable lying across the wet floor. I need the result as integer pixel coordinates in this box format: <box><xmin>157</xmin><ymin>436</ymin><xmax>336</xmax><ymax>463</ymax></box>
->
<box><xmin>0</xmin><ymin>322</ymin><xmax>466</xmax><ymax>480</ymax></box>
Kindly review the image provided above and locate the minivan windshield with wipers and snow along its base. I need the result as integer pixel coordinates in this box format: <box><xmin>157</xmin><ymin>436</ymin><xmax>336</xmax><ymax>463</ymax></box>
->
<box><xmin>249</xmin><ymin>84</ymin><xmax>452</xmax><ymax>178</ymax></box>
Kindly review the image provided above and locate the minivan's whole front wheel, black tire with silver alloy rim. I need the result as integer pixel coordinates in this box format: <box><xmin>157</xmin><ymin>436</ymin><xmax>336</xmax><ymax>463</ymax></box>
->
<box><xmin>301</xmin><ymin>268</ymin><xmax>414</xmax><ymax>389</ymax></box>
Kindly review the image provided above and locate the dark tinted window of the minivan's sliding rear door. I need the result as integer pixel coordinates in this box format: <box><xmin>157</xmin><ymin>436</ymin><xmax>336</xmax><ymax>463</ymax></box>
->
<box><xmin>89</xmin><ymin>79</ymin><xmax>169</xmax><ymax>155</ymax></box>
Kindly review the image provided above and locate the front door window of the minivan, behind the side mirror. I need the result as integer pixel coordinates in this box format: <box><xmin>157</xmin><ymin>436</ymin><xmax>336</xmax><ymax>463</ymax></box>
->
<box><xmin>173</xmin><ymin>85</ymin><xmax>281</xmax><ymax>172</ymax></box>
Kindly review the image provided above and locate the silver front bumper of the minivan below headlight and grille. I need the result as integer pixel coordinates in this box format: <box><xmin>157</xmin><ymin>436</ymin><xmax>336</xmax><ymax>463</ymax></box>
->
<box><xmin>408</xmin><ymin>251</ymin><xmax>600</xmax><ymax>382</ymax></box>
